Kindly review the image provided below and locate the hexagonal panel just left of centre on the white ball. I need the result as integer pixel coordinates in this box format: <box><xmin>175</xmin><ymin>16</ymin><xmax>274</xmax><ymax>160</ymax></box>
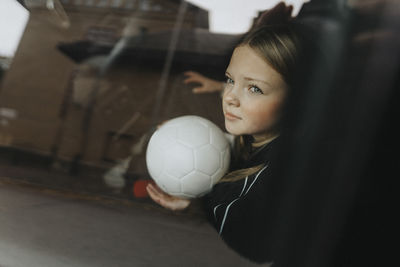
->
<box><xmin>164</xmin><ymin>143</ymin><xmax>194</xmax><ymax>178</ymax></box>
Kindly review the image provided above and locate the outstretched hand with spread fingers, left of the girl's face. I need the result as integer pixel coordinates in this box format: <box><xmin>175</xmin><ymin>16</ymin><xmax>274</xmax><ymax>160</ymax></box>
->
<box><xmin>183</xmin><ymin>71</ymin><xmax>224</xmax><ymax>94</ymax></box>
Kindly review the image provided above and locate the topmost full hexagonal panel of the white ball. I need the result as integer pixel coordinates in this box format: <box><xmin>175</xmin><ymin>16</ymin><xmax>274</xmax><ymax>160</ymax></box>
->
<box><xmin>177</xmin><ymin>120</ymin><xmax>210</xmax><ymax>147</ymax></box>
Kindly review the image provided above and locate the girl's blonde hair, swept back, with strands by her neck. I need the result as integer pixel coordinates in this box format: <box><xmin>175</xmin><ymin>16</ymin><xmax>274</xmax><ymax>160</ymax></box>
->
<box><xmin>219</xmin><ymin>23</ymin><xmax>299</xmax><ymax>182</ymax></box>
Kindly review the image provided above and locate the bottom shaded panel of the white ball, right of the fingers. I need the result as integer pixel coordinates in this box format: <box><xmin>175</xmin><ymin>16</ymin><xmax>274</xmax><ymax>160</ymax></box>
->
<box><xmin>181</xmin><ymin>171</ymin><xmax>212</xmax><ymax>197</ymax></box>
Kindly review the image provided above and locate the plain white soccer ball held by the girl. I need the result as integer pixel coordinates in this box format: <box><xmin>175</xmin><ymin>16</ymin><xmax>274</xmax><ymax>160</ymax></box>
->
<box><xmin>146</xmin><ymin>115</ymin><xmax>230</xmax><ymax>198</ymax></box>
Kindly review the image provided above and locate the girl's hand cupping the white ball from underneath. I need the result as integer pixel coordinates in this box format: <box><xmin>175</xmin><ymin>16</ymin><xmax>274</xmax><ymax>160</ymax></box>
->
<box><xmin>146</xmin><ymin>183</ymin><xmax>190</xmax><ymax>211</ymax></box>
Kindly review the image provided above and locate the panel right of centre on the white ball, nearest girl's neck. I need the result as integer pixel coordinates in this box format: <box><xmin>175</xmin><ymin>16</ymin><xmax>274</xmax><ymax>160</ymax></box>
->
<box><xmin>194</xmin><ymin>145</ymin><xmax>221</xmax><ymax>176</ymax></box>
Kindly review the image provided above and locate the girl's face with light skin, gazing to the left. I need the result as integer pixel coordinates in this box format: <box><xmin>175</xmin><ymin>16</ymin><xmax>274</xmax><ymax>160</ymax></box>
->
<box><xmin>222</xmin><ymin>46</ymin><xmax>287</xmax><ymax>141</ymax></box>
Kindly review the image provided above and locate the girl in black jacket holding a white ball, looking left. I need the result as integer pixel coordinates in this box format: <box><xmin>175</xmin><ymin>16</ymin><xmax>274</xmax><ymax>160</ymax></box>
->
<box><xmin>147</xmin><ymin>24</ymin><xmax>299</xmax><ymax>263</ymax></box>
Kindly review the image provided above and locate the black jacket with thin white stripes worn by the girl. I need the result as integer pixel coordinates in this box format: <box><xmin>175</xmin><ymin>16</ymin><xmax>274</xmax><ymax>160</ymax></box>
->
<box><xmin>202</xmin><ymin>140</ymin><xmax>282</xmax><ymax>263</ymax></box>
